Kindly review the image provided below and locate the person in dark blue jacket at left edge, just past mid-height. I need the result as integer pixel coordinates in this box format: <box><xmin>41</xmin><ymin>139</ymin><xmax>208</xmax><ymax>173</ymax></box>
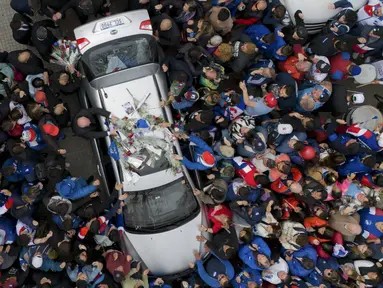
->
<box><xmin>1</xmin><ymin>158</ymin><xmax>36</xmax><ymax>182</ymax></box>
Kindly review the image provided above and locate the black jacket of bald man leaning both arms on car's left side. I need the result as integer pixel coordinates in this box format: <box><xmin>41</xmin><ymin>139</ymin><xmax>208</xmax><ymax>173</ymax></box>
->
<box><xmin>72</xmin><ymin>108</ymin><xmax>110</xmax><ymax>139</ymax></box>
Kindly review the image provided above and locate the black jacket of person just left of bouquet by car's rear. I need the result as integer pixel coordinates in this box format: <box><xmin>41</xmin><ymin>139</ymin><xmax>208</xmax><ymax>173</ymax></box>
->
<box><xmin>32</xmin><ymin>19</ymin><xmax>57</xmax><ymax>61</ymax></box>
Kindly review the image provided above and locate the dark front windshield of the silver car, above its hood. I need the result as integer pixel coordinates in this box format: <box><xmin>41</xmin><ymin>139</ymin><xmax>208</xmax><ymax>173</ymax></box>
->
<box><xmin>124</xmin><ymin>177</ymin><xmax>199</xmax><ymax>232</ymax></box>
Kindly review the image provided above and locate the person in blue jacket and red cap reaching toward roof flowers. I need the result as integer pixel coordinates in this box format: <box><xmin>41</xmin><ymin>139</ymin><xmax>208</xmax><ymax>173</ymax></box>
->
<box><xmin>174</xmin><ymin>135</ymin><xmax>217</xmax><ymax>170</ymax></box>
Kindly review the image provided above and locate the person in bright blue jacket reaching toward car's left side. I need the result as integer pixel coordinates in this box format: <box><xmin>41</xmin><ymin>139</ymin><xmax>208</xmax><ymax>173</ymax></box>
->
<box><xmin>56</xmin><ymin>177</ymin><xmax>100</xmax><ymax>200</ymax></box>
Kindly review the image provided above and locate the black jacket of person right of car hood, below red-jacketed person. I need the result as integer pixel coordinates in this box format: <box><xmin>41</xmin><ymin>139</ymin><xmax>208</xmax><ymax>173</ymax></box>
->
<box><xmin>206</xmin><ymin>227</ymin><xmax>239</xmax><ymax>260</ymax></box>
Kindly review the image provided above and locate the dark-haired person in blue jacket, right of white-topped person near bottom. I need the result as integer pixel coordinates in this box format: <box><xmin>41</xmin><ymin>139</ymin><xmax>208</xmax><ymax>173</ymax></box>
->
<box><xmin>282</xmin><ymin>245</ymin><xmax>318</xmax><ymax>277</ymax></box>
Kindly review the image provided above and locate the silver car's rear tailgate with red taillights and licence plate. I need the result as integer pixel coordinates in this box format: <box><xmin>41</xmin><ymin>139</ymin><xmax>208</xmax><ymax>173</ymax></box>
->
<box><xmin>74</xmin><ymin>10</ymin><xmax>152</xmax><ymax>54</ymax></box>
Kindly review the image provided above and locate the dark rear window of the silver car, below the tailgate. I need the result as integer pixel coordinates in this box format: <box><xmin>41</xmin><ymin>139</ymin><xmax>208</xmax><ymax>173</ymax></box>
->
<box><xmin>82</xmin><ymin>35</ymin><xmax>157</xmax><ymax>79</ymax></box>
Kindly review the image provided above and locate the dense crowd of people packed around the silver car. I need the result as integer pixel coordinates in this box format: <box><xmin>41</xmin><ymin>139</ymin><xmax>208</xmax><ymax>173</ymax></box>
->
<box><xmin>0</xmin><ymin>0</ymin><xmax>383</xmax><ymax>288</ymax></box>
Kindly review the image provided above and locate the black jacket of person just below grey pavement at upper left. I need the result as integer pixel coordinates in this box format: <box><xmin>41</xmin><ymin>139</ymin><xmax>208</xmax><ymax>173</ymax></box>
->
<box><xmin>7</xmin><ymin>50</ymin><xmax>44</xmax><ymax>76</ymax></box>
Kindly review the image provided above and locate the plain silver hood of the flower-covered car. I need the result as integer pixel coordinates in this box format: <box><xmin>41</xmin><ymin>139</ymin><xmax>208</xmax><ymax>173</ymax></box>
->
<box><xmin>125</xmin><ymin>211</ymin><xmax>203</xmax><ymax>276</ymax></box>
